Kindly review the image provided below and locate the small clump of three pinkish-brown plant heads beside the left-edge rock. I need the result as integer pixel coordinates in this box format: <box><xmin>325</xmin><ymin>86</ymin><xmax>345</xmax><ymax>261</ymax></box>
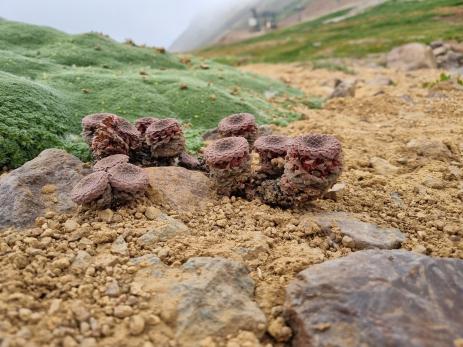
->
<box><xmin>71</xmin><ymin>154</ymin><xmax>149</xmax><ymax>209</ymax></box>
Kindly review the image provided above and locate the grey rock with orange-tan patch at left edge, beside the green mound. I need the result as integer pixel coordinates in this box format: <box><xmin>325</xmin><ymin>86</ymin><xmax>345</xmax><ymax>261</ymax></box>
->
<box><xmin>0</xmin><ymin>149</ymin><xmax>89</xmax><ymax>229</ymax></box>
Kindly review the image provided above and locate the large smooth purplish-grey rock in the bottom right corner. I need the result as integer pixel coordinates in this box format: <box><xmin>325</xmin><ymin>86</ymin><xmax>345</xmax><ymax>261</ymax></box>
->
<box><xmin>285</xmin><ymin>250</ymin><xmax>463</xmax><ymax>347</ymax></box>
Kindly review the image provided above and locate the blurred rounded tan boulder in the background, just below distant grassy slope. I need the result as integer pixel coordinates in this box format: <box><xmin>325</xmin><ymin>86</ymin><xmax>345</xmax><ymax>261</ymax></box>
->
<box><xmin>387</xmin><ymin>43</ymin><xmax>437</xmax><ymax>71</ymax></box>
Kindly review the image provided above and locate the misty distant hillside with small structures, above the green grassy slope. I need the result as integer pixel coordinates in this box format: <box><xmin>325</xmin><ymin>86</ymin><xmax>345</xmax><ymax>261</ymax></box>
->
<box><xmin>170</xmin><ymin>0</ymin><xmax>384</xmax><ymax>52</ymax></box>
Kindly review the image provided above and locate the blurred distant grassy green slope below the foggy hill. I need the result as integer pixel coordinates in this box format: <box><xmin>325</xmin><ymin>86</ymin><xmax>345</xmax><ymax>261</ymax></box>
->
<box><xmin>201</xmin><ymin>0</ymin><xmax>463</xmax><ymax>64</ymax></box>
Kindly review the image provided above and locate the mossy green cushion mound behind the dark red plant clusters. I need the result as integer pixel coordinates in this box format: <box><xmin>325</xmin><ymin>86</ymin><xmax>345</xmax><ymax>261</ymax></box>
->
<box><xmin>0</xmin><ymin>20</ymin><xmax>301</xmax><ymax>168</ymax></box>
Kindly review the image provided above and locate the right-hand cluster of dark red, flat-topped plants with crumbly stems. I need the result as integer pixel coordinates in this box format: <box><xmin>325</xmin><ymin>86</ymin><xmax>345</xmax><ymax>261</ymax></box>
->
<box><xmin>204</xmin><ymin>114</ymin><xmax>342</xmax><ymax>207</ymax></box>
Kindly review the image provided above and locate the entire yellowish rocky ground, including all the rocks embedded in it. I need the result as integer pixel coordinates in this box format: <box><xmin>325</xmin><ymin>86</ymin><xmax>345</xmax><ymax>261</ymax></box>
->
<box><xmin>0</xmin><ymin>52</ymin><xmax>463</xmax><ymax>347</ymax></box>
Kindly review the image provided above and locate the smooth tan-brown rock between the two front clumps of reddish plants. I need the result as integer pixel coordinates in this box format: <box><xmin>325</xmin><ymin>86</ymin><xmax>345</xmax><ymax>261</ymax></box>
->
<box><xmin>146</xmin><ymin>166</ymin><xmax>213</xmax><ymax>212</ymax></box>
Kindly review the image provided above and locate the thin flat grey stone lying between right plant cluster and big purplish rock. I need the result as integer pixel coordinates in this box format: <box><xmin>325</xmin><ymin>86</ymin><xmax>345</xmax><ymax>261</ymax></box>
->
<box><xmin>314</xmin><ymin>212</ymin><xmax>405</xmax><ymax>249</ymax></box>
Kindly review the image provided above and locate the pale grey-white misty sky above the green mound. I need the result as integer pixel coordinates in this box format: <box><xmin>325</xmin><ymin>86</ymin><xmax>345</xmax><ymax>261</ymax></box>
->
<box><xmin>0</xmin><ymin>0</ymin><xmax>244</xmax><ymax>48</ymax></box>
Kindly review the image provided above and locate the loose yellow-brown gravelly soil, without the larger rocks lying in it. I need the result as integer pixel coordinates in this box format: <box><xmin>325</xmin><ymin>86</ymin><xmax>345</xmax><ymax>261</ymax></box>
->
<box><xmin>0</xmin><ymin>65</ymin><xmax>463</xmax><ymax>347</ymax></box>
